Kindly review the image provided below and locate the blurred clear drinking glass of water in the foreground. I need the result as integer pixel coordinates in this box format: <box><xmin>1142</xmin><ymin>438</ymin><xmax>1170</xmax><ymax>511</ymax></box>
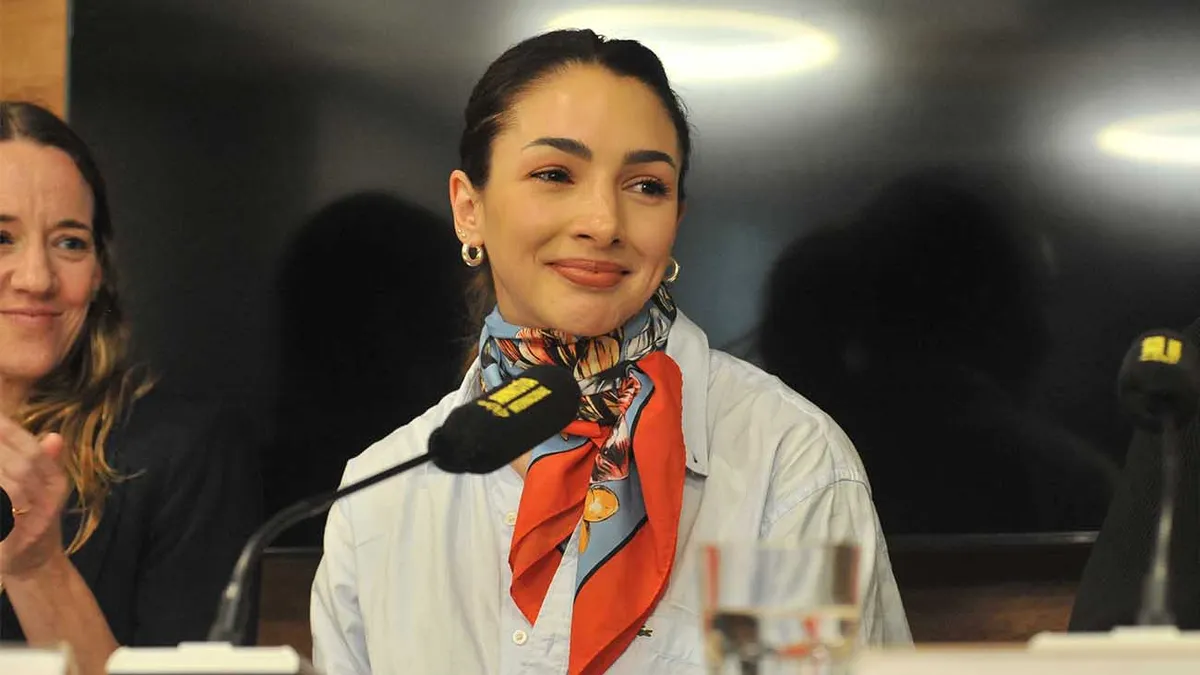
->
<box><xmin>700</xmin><ymin>542</ymin><xmax>859</xmax><ymax>675</ymax></box>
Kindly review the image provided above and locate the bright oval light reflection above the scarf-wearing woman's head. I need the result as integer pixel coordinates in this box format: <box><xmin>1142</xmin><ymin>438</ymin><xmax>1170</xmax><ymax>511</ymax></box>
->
<box><xmin>545</xmin><ymin>5</ymin><xmax>838</xmax><ymax>83</ymax></box>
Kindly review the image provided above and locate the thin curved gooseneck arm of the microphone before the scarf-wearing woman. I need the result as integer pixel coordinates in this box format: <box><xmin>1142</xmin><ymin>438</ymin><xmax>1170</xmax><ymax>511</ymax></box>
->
<box><xmin>209</xmin><ymin>453</ymin><xmax>433</xmax><ymax>646</ymax></box>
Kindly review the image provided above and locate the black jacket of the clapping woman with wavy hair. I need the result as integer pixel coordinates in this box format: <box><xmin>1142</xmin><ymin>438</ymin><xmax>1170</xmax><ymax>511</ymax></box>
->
<box><xmin>0</xmin><ymin>393</ymin><xmax>263</xmax><ymax>646</ymax></box>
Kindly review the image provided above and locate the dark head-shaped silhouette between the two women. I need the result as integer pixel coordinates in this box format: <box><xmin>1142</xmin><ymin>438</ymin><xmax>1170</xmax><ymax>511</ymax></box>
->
<box><xmin>265</xmin><ymin>192</ymin><xmax>467</xmax><ymax>545</ymax></box>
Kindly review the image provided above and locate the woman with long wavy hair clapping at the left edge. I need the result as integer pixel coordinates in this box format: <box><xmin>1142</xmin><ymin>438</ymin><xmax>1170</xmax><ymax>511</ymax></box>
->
<box><xmin>0</xmin><ymin>102</ymin><xmax>259</xmax><ymax>674</ymax></box>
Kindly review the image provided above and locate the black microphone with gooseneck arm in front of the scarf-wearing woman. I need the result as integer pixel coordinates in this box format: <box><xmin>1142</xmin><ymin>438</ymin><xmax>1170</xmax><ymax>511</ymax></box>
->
<box><xmin>209</xmin><ymin>365</ymin><xmax>581</xmax><ymax>645</ymax></box>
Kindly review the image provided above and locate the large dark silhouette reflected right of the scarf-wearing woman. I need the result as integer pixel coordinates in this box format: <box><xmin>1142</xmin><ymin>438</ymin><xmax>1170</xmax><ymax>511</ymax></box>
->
<box><xmin>760</xmin><ymin>168</ymin><xmax>1116</xmax><ymax>534</ymax></box>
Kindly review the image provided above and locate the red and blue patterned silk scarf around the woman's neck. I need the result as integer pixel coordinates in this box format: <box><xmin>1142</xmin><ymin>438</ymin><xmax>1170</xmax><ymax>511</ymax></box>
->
<box><xmin>479</xmin><ymin>287</ymin><xmax>685</xmax><ymax>675</ymax></box>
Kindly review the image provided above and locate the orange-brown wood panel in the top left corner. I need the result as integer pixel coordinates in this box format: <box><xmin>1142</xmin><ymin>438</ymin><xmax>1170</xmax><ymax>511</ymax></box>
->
<box><xmin>0</xmin><ymin>0</ymin><xmax>71</xmax><ymax>117</ymax></box>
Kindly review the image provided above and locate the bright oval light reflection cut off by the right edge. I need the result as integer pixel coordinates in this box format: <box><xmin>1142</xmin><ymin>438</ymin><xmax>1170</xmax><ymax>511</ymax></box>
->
<box><xmin>1096</xmin><ymin>110</ymin><xmax>1200</xmax><ymax>167</ymax></box>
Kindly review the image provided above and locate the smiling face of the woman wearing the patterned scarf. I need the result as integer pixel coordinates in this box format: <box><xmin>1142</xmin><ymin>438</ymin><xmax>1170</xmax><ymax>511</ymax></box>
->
<box><xmin>450</xmin><ymin>65</ymin><xmax>682</xmax><ymax>336</ymax></box>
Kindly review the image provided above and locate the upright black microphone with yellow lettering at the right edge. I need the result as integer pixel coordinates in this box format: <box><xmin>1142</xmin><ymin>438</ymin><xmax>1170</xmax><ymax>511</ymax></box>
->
<box><xmin>1117</xmin><ymin>330</ymin><xmax>1200</xmax><ymax>626</ymax></box>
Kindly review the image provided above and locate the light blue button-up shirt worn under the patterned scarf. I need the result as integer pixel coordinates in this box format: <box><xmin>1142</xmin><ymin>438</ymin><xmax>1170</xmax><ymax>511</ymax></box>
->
<box><xmin>312</xmin><ymin>313</ymin><xmax>912</xmax><ymax>675</ymax></box>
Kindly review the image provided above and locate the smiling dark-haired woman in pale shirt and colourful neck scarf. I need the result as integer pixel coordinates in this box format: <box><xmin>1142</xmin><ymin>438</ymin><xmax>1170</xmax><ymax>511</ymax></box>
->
<box><xmin>312</xmin><ymin>31</ymin><xmax>910</xmax><ymax>675</ymax></box>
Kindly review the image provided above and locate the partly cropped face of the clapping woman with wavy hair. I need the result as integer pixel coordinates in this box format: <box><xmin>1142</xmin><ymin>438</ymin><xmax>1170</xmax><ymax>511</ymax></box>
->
<box><xmin>0</xmin><ymin>139</ymin><xmax>101</xmax><ymax>388</ymax></box>
